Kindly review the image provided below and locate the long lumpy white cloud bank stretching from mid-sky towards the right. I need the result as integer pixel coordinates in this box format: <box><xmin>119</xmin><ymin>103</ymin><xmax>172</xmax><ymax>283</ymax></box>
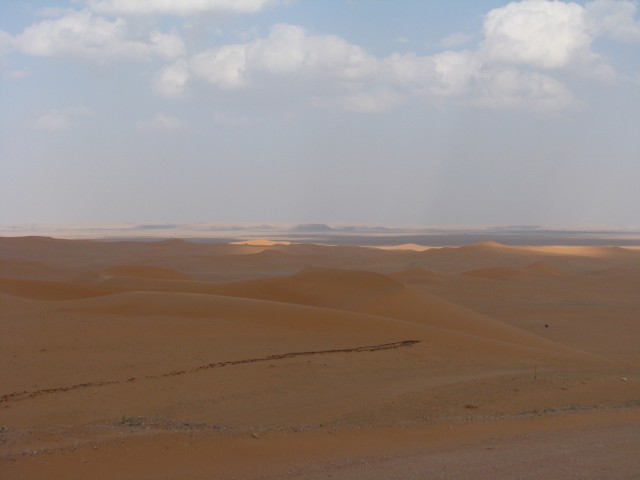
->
<box><xmin>184</xmin><ymin>20</ymin><xmax>573</xmax><ymax>113</ymax></box>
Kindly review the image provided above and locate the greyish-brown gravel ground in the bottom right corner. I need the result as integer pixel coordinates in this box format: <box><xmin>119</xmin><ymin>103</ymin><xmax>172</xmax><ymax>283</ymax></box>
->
<box><xmin>278</xmin><ymin>424</ymin><xmax>640</xmax><ymax>480</ymax></box>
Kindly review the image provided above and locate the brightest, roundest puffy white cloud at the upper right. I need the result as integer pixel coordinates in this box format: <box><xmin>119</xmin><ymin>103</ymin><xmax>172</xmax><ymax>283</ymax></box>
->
<box><xmin>480</xmin><ymin>0</ymin><xmax>592</xmax><ymax>69</ymax></box>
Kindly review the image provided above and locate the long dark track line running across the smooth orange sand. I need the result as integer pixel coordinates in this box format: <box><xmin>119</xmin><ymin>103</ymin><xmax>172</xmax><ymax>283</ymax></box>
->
<box><xmin>0</xmin><ymin>340</ymin><xmax>420</xmax><ymax>403</ymax></box>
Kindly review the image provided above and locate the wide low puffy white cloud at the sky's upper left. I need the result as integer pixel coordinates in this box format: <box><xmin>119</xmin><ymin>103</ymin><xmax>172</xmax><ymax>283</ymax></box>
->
<box><xmin>12</xmin><ymin>11</ymin><xmax>185</xmax><ymax>61</ymax></box>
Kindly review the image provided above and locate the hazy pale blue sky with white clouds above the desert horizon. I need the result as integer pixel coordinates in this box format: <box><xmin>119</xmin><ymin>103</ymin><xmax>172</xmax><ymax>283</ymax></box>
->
<box><xmin>0</xmin><ymin>0</ymin><xmax>640</xmax><ymax>226</ymax></box>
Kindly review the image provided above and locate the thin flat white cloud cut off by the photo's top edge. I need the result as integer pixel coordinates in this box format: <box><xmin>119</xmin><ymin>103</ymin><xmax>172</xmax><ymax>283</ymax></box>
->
<box><xmin>87</xmin><ymin>0</ymin><xmax>278</xmax><ymax>16</ymax></box>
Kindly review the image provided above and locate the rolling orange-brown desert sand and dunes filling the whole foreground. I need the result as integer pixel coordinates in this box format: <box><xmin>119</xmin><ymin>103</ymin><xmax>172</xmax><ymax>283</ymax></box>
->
<box><xmin>0</xmin><ymin>237</ymin><xmax>640</xmax><ymax>479</ymax></box>
